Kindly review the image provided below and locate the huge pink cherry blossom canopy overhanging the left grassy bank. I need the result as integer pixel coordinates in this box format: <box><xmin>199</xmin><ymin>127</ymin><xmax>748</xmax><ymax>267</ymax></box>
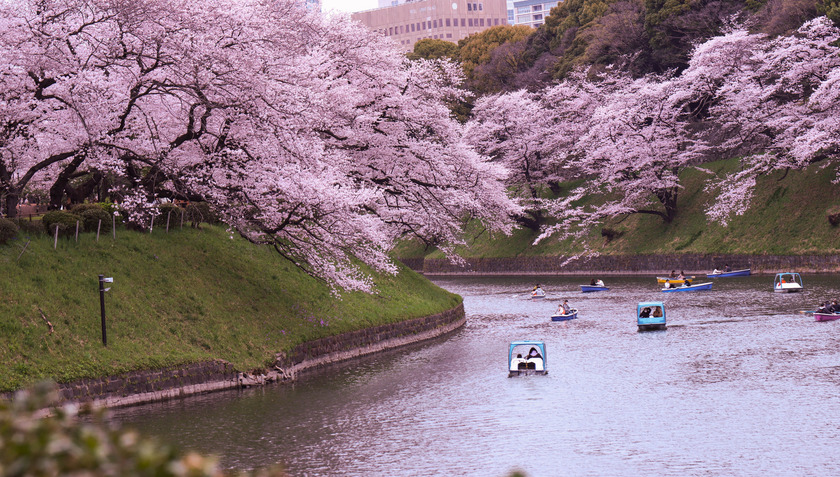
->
<box><xmin>0</xmin><ymin>0</ymin><xmax>518</xmax><ymax>291</ymax></box>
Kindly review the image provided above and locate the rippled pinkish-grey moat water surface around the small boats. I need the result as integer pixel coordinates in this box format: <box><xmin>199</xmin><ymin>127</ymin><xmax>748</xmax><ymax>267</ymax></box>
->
<box><xmin>108</xmin><ymin>276</ymin><xmax>840</xmax><ymax>476</ymax></box>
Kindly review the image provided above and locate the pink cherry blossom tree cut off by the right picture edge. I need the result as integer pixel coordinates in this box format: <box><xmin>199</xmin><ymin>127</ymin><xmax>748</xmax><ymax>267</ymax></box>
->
<box><xmin>705</xmin><ymin>17</ymin><xmax>840</xmax><ymax>224</ymax></box>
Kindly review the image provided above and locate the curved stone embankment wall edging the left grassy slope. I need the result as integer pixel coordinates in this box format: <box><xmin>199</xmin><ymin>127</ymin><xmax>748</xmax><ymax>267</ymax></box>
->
<box><xmin>42</xmin><ymin>304</ymin><xmax>466</xmax><ymax>407</ymax></box>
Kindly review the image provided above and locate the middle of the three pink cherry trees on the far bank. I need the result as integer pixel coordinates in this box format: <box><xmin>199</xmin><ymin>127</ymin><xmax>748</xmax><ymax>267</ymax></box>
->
<box><xmin>540</xmin><ymin>70</ymin><xmax>705</xmax><ymax>239</ymax></box>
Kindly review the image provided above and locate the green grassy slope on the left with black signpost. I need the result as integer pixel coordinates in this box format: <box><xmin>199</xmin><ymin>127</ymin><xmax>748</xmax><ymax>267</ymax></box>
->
<box><xmin>0</xmin><ymin>227</ymin><xmax>460</xmax><ymax>391</ymax></box>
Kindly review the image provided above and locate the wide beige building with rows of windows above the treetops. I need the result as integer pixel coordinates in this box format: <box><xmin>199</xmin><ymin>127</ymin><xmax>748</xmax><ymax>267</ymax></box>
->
<box><xmin>352</xmin><ymin>0</ymin><xmax>508</xmax><ymax>51</ymax></box>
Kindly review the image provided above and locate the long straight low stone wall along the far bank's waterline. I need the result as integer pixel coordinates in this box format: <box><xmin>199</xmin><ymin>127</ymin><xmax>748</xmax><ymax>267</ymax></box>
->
<box><xmin>422</xmin><ymin>253</ymin><xmax>840</xmax><ymax>275</ymax></box>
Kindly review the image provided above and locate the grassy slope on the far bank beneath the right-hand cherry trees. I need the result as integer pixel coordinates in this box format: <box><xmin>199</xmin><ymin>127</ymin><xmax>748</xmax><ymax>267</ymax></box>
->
<box><xmin>398</xmin><ymin>160</ymin><xmax>840</xmax><ymax>258</ymax></box>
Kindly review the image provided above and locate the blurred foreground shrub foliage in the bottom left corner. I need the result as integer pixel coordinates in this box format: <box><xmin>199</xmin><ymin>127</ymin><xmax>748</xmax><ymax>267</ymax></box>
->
<box><xmin>0</xmin><ymin>382</ymin><xmax>287</xmax><ymax>477</ymax></box>
